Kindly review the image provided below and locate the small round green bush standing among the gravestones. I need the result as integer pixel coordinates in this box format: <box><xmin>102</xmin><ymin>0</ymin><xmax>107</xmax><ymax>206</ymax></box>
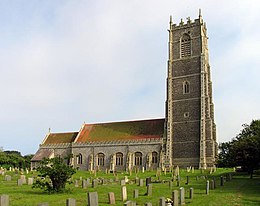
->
<box><xmin>33</xmin><ymin>157</ymin><xmax>76</xmax><ymax>193</ymax></box>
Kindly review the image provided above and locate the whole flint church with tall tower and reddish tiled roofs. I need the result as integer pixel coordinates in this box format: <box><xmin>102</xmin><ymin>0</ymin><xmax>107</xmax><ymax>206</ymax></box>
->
<box><xmin>31</xmin><ymin>14</ymin><xmax>217</xmax><ymax>171</ymax></box>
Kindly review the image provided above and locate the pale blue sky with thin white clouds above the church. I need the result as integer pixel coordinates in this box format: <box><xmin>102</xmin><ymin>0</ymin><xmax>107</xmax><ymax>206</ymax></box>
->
<box><xmin>0</xmin><ymin>0</ymin><xmax>260</xmax><ymax>155</ymax></box>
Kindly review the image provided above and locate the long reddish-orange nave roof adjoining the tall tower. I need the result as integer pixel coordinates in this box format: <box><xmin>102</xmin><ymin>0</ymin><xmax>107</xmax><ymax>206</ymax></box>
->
<box><xmin>75</xmin><ymin>119</ymin><xmax>165</xmax><ymax>143</ymax></box>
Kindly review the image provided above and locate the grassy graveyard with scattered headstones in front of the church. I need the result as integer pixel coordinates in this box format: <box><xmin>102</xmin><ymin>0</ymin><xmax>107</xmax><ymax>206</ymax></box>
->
<box><xmin>0</xmin><ymin>167</ymin><xmax>260</xmax><ymax>206</ymax></box>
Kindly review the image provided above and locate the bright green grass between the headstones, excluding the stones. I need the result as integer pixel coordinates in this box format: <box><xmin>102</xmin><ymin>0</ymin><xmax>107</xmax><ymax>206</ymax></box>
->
<box><xmin>0</xmin><ymin>169</ymin><xmax>260</xmax><ymax>206</ymax></box>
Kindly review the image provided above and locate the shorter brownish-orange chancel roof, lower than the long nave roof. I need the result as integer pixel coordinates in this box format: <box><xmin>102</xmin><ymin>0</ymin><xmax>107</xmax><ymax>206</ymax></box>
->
<box><xmin>42</xmin><ymin>132</ymin><xmax>78</xmax><ymax>145</ymax></box>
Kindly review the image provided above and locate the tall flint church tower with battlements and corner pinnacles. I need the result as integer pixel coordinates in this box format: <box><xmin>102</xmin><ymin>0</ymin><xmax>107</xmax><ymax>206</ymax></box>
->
<box><xmin>164</xmin><ymin>14</ymin><xmax>217</xmax><ymax>168</ymax></box>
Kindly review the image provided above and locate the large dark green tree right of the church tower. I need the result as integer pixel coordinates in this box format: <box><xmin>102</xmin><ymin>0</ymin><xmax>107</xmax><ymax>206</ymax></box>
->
<box><xmin>218</xmin><ymin>120</ymin><xmax>260</xmax><ymax>178</ymax></box>
